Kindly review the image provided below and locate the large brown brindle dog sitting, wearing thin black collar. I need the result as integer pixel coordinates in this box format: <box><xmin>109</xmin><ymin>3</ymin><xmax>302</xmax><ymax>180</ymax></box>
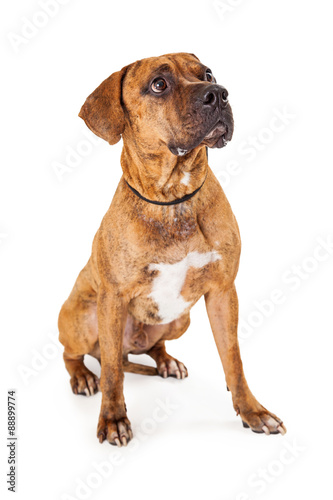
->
<box><xmin>59</xmin><ymin>53</ymin><xmax>285</xmax><ymax>446</ymax></box>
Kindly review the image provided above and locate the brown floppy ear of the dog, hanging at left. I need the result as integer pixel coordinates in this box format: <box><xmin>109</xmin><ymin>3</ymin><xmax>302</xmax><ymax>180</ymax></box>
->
<box><xmin>79</xmin><ymin>66</ymin><xmax>128</xmax><ymax>144</ymax></box>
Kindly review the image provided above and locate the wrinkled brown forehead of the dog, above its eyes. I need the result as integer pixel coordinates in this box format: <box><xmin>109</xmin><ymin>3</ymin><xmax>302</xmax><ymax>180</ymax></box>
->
<box><xmin>126</xmin><ymin>52</ymin><xmax>204</xmax><ymax>82</ymax></box>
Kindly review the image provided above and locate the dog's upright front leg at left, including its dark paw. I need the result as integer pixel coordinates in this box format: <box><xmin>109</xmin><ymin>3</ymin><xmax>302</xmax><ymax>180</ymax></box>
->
<box><xmin>97</xmin><ymin>286</ymin><xmax>133</xmax><ymax>446</ymax></box>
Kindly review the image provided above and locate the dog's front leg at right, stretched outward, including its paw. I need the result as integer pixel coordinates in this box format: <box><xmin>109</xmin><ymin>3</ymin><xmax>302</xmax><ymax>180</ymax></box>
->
<box><xmin>205</xmin><ymin>285</ymin><xmax>286</xmax><ymax>434</ymax></box>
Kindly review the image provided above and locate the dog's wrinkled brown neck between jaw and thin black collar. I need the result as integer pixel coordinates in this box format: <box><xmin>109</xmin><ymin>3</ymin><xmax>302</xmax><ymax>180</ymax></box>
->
<box><xmin>121</xmin><ymin>140</ymin><xmax>208</xmax><ymax>202</ymax></box>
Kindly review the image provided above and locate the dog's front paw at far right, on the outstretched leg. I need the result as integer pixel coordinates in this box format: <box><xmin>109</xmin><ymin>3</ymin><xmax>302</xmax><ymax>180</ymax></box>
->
<box><xmin>240</xmin><ymin>405</ymin><xmax>287</xmax><ymax>435</ymax></box>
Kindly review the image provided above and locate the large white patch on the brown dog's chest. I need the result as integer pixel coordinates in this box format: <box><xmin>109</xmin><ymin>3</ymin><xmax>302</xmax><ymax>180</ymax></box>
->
<box><xmin>149</xmin><ymin>250</ymin><xmax>221</xmax><ymax>323</ymax></box>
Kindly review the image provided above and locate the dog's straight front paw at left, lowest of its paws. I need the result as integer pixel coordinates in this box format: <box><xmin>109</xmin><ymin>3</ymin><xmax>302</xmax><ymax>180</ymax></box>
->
<box><xmin>97</xmin><ymin>416</ymin><xmax>133</xmax><ymax>447</ymax></box>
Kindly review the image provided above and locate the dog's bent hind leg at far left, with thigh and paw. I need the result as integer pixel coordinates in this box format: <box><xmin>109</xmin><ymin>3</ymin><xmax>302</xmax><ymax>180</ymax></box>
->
<box><xmin>58</xmin><ymin>262</ymin><xmax>99</xmax><ymax>396</ymax></box>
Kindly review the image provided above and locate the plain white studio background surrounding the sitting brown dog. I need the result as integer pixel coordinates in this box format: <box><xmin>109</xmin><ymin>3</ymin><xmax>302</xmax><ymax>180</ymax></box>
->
<box><xmin>0</xmin><ymin>0</ymin><xmax>333</xmax><ymax>500</ymax></box>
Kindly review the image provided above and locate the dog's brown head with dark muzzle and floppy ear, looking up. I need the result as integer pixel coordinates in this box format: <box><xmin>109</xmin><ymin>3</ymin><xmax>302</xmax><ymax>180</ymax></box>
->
<box><xmin>79</xmin><ymin>53</ymin><xmax>233</xmax><ymax>156</ymax></box>
